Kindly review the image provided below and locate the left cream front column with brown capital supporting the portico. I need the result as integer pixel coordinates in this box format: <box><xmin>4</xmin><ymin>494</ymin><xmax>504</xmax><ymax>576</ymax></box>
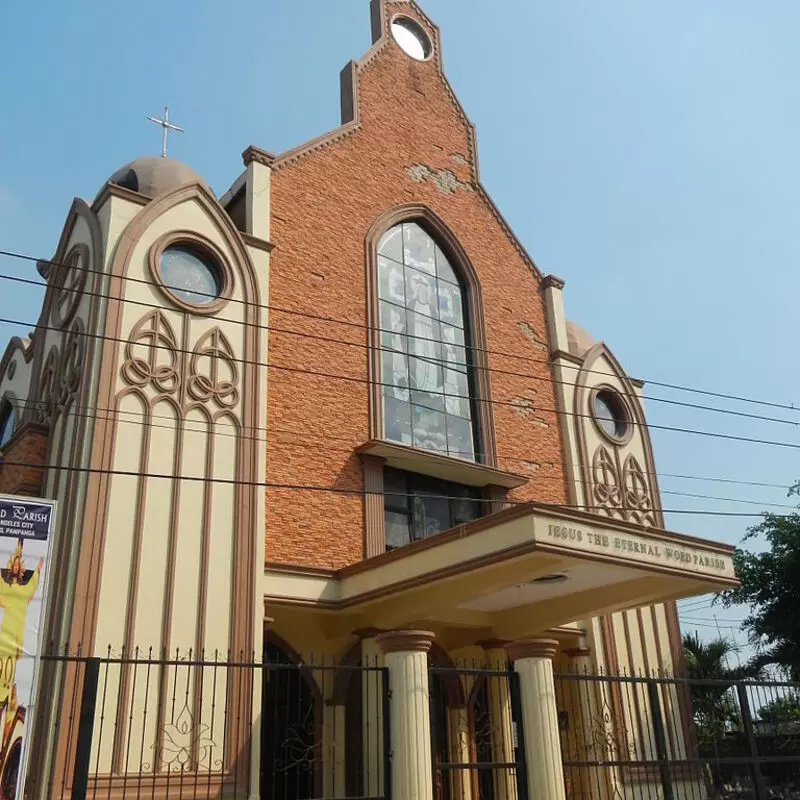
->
<box><xmin>376</xmin><ymin>631</ymin><xmax>434</xmax><ymax>800</ymax></box>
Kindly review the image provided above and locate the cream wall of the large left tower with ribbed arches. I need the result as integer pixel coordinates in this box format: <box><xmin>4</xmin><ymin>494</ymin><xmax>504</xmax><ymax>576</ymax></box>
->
<box><xmin>77</xmin><ymin>181</ymin><xmax>269</xmax><ymax>773</ymax></box>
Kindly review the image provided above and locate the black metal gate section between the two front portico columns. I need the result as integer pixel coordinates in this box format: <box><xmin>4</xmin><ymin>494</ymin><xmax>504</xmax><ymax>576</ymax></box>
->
<box><xmin>428</xmin><ymin>665</ymin><xmax>528</xmax><ymax>800</ymax></box>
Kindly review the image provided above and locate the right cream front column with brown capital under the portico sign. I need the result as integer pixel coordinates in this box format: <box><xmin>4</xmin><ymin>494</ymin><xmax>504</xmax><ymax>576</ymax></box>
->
<box><xmin>506</xmin><ymin>639</ymin><xmax>566</xmax><ymax>800</ymax></box>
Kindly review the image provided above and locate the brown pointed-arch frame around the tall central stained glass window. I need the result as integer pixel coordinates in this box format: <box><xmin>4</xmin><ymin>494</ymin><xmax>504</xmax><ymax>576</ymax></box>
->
<box><xmin>366</xmin><ymin>204</ymin><xmax>497</xmax><ymax>467</ymax></box>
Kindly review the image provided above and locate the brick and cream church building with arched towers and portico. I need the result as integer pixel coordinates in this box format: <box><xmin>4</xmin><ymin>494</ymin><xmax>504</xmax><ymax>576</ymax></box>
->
<box><xmin>0</xmin><ymin>0</ymin><xmax>735</xmax><ymax>800</ymax></box>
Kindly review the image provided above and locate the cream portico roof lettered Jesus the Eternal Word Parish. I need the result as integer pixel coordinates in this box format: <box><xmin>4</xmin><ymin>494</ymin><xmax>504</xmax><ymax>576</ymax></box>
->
<box><xmin>264</xmin><ymin>503</ymin><xmax>737</xmax><ymax>638</ymax></box>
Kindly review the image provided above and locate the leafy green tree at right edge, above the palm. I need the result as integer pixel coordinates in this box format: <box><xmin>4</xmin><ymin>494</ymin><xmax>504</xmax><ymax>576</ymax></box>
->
<box><xmin>719</xmin><ymin>500</ymin><xmax>800</xmax><ymax>681</ymax></box>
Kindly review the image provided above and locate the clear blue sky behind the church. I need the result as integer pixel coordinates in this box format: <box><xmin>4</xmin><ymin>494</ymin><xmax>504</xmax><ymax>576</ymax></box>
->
<box><xmin>0</xmin><ymin>0</ymin><xmax>800</xmax><ymax>660</ymax></box>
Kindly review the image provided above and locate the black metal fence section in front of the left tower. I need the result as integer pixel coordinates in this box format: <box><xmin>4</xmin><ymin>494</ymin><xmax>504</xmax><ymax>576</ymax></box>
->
<box><xmin>33</xmin><ymin>646</ymin><xmax>391</xmax><ymax>800</ymax></box>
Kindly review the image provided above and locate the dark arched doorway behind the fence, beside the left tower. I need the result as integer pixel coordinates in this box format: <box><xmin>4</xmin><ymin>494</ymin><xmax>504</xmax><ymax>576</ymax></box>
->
<box><xmin>261</xmin><ymin>636</ymin><xmax>322</xmax><ymax>800</ymax></box>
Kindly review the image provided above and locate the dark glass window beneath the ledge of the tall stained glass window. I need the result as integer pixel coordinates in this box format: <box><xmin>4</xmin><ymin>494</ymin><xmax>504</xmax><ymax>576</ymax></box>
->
<box><xmin>383</xmin><ymin>468</ymin><xmax>486</xmax><ymax>550</ymax></box>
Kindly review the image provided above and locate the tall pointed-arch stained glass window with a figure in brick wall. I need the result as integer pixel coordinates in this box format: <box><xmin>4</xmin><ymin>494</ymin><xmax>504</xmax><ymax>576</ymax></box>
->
<box><xmin>378</xmin><ymin>222</ymin><xmax>475</xmax><ymax>461</ymax></box>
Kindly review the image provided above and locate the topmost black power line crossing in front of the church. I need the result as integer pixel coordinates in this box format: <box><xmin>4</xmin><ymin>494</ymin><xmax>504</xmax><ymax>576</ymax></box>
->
<box><xmin>6</xmin><ymin>245</ymin><xmax>800</xmax><ymax>416</ymax></box>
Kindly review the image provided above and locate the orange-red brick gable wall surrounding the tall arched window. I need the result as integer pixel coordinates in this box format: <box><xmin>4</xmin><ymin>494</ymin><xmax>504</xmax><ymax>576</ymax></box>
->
<box><xmin>266</xmin><ymin>6</ymin><xmax>566</xmax><ymax>567</ymax></box>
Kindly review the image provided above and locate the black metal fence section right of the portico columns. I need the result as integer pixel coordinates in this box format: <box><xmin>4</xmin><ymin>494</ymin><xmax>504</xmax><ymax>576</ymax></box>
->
<box><xmin>555</xmin><ymin>674</ymin><xmax>800</xmax><ymax>800</ymax></box>
